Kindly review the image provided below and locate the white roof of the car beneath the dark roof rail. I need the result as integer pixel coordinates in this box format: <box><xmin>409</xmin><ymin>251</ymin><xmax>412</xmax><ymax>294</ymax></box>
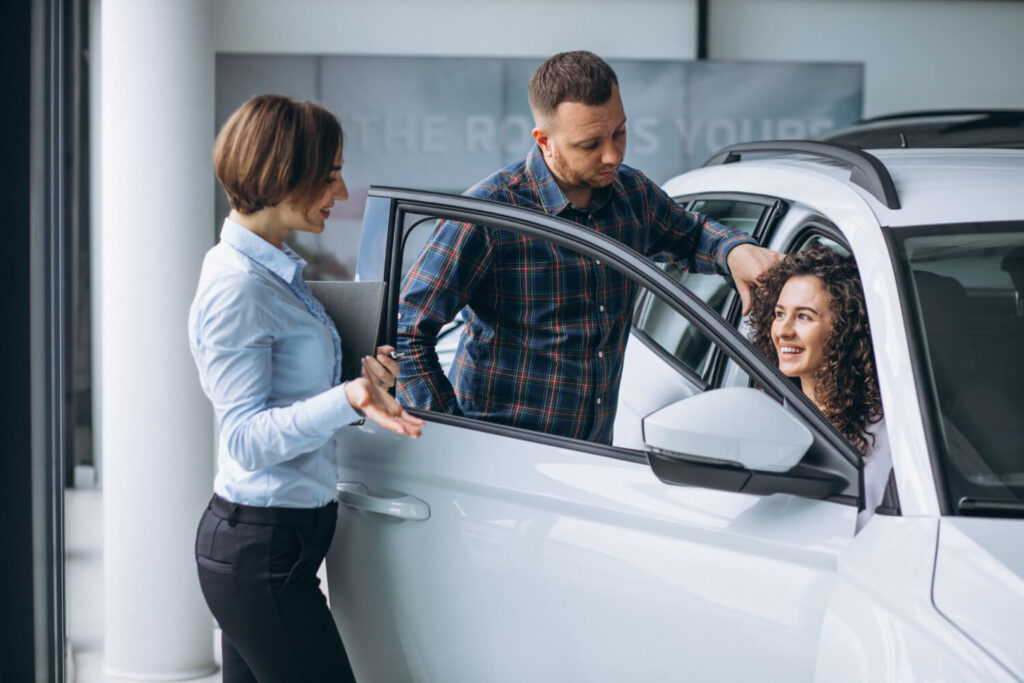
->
<box><xmin>665</xmin><ymin>148</ymin><xmax>1024</xmax><ymax>227</ymax></box>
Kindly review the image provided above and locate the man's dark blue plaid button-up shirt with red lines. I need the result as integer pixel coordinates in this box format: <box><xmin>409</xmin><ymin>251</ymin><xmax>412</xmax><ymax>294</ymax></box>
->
<box><xmin>398</xmin><ymin>145</ymin><xmax>754</xmax><ymax>443</ymax></box>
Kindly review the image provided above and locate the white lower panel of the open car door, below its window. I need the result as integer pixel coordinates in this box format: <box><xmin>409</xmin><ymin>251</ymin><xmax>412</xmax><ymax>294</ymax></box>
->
<box><xmin>328</xmin><ymin>413</ymin><xmax>856</xmax><ymax>683</ymax></box>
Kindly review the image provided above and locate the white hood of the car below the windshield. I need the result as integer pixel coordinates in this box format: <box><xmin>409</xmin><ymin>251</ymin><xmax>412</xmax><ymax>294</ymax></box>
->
<box><xmin>932</xmin><ymin>517</ymin><xmax>1024</xmax><ymax>676</ymax></box>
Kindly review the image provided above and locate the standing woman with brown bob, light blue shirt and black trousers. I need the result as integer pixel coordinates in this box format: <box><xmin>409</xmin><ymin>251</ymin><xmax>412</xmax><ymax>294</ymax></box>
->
<box><xmin>188</xmin><ymin>95</ymin><xmax>423</xmax><ymax>682</ymax></box>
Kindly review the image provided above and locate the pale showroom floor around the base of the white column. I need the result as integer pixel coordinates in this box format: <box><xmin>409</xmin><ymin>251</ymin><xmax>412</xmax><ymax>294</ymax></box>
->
<box><xmin>65</xmin><ymin>487</ymin><xmax>221</xmax><ymax>683</ymax></box>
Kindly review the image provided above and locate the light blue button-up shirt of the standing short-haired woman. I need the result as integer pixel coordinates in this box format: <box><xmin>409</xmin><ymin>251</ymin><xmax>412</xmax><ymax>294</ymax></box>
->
<box><xmin>188</xmin><ymin>219</ymin><xmax>360</xmax><ymax>508</ymax></box>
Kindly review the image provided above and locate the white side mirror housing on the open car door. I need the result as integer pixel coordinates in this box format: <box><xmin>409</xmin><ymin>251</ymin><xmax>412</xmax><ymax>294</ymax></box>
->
<box><xmin>643</xmin><ymin>387</ymin><xmax>814</xmax><ymax>472</ymax></box>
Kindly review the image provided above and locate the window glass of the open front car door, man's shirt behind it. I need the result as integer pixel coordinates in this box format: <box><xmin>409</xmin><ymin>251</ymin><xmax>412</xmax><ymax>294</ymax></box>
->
<box><xmin>392</xmin><ymin>205</ymin><xmax>745</xmax><ymax>447</ymax></box>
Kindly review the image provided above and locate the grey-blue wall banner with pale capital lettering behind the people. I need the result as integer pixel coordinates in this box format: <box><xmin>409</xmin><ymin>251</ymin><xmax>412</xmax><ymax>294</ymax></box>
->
<box><xmin>215</xmin><ymin>54</ymin><xmax>863</xmax><ymax>278</ymax></box>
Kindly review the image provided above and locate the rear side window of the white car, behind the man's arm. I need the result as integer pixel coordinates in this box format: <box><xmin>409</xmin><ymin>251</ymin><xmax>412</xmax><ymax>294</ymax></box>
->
<box><xmin>633</xmin><ymin>199</ymin><xmax>771</xmax><ymax>378</ymax></box>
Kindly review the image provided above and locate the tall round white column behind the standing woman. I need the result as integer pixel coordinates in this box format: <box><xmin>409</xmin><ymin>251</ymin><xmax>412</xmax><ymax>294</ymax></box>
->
<box><xmin>93</xmin><ymin>0</ymin><xmax>215</xmax><ymax>680</ymax></box>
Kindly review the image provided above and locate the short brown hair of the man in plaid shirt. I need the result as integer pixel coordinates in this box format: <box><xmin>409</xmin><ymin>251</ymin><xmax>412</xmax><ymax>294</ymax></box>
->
<box><xmin>529</xmin><ymin>50</ymin><xmax>618</xmax><ymax>118</ymax></box>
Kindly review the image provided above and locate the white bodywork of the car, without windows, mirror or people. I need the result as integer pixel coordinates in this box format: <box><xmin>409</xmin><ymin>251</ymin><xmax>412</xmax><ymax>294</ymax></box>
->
<box><xmin>328</xmin><ymin>151</ymin><xmax>1024</xmax><ymax>683</ymax></box>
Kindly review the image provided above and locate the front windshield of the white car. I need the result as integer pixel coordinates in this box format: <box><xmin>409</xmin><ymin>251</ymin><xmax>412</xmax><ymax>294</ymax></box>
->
<box><xmin>894</xmin><ymin>222</ymin><xmax>1024</xmax><ymax>516</ymax></box>
